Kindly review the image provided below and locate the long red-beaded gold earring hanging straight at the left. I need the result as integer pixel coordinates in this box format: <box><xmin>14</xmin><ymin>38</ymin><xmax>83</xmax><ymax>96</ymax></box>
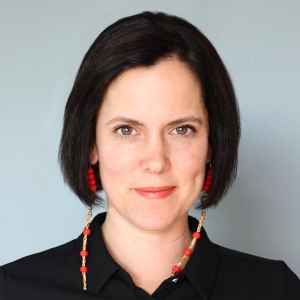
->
<box><xmin>79</xmin><ymin>167</ymin><xmax>97</xmax><ymax>290</ymax></box>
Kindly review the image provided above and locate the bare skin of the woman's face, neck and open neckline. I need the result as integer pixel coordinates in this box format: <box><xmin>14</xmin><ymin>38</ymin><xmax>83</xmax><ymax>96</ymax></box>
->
<box><xmin>90</xmin><ymin>59</ymin><xmax>211</xmax><ymax>294</ymax></box>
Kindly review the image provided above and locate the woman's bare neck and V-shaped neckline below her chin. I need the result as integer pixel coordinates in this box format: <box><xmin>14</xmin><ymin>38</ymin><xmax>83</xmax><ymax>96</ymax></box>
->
<box><xmin>101</xmin><ymin>210</ymin><xmax>191</xmax><ymax>294</ymax></box>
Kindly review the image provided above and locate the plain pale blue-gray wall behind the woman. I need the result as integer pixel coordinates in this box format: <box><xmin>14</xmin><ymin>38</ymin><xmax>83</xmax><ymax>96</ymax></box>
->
<box><xmin>0</xmin><ymin>0</ymin><xmax>300</xmax><ymax>276</ymax></box>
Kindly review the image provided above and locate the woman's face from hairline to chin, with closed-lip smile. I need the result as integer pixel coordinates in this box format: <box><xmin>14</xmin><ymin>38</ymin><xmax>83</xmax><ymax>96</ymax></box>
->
<box><xmin>91</xmin><ymin>59</ymin><xmax>210</xmax><ymax>231</ymax></box>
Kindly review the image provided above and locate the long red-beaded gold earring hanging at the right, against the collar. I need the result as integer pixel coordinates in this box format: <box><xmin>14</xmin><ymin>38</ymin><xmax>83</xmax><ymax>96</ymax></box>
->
<box><xmin>172</xmin><ymin>164</ymin><xmax>212</xmax><ymax>276</ymax></box>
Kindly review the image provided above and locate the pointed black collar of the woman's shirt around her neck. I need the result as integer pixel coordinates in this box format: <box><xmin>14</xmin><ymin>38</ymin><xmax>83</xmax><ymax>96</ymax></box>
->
<box><xmin>77</xmin><ymin>213</ymin><xmax>218</xmax><ymax>299</ymax></box>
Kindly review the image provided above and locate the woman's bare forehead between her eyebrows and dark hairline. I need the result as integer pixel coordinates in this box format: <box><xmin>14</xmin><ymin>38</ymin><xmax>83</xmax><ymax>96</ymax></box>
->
<box><xmin>100</xmin><ymin>59</ymin><xmax>205</xmax><ymax>116</ymax></box>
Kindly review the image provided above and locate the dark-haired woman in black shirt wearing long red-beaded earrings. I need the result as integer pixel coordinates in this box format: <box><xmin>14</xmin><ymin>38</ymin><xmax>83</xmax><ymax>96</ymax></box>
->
<box><xmin>0</xmin><ymin>12</ymin><xmax>300</xmax><ymax>300</ymax></box>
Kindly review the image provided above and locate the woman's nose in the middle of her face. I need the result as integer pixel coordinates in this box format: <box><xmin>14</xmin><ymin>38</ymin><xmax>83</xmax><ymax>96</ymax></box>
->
<box><xmin>141</xmin><ymin>135</ymin><xmax>170</xmax><ymax>174</ymax></box>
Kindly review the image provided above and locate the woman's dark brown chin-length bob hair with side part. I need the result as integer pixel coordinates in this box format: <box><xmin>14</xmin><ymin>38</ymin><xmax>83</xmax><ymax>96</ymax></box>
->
<box><xmin>59</xmin><ymin>12</ymin><xmax>240</xmax><ymax>208</ymax></box>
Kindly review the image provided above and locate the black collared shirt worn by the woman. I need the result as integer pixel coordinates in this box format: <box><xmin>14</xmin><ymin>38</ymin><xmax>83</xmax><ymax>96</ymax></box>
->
<box><xmin>0</xmin><ymin>213</ymin><xmax>300</xmax><ymax>300</ymax></box>
